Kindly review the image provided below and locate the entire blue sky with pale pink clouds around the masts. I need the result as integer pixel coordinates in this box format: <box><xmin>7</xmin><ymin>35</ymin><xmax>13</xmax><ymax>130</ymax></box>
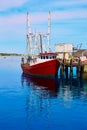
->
<box><xmin>0</xmin><ymin>0</ymin><xmax>87</xmax><ymax>53</ymax></box>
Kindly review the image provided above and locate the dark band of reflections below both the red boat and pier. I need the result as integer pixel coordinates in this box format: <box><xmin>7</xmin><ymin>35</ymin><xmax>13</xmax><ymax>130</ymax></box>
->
<box><xmin>21</xmin><ymin>73</ymin><xmax>87</xmax><ymax>100</ymax></box>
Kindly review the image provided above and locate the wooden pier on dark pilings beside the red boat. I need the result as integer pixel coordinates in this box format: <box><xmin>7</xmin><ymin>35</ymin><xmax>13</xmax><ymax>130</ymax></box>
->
<box><xmin>60</xmin><ymin>59</ymin><xmax>85</xmax><ymax>79</ymax></box>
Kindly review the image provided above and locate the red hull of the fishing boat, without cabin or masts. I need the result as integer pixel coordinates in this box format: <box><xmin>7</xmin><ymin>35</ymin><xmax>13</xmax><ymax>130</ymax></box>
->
<box><xmin>21</xmin><ymin>59</ymin><xmax>60</xmax><ymax>76</ymax></box>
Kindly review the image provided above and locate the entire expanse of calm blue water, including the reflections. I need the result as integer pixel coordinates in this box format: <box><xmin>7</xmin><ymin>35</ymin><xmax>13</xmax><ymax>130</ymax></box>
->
<box><xmin>0</xmin><ymin>57</ymin><xmax>87</xmax><ymax>130</ymax></box>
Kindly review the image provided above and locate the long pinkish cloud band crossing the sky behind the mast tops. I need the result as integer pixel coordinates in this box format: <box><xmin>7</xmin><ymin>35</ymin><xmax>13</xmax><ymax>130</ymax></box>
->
<box><xmin>0</xmin><ymin>9</ymin><xmax>87</xmax><ymax>31</ymax></box>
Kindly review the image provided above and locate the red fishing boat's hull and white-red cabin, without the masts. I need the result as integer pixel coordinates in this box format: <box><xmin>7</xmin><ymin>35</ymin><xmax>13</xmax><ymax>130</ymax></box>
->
<box><xmin>21</xmin><ymin>52</ymin><xmax>60</xmax><ymax>77</ymax></box>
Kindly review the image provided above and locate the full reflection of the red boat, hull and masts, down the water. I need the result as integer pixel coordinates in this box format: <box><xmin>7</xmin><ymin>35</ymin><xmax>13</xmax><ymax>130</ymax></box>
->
<box><xmin>21</xmin><ymin>74</ymin><xmax>59</xmax><ymax>130</ymax></box>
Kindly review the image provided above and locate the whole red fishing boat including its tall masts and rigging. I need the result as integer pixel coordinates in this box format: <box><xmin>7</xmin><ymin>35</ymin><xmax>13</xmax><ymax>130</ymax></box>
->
<box><xmin>21</xmin><ymin>12</ymin><xmax>60</xmax><ymax>77</ymax></box>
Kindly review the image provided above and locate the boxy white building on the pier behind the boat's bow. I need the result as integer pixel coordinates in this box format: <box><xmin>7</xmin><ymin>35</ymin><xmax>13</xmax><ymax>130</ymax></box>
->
<box><xmin>55</xmin><ymin>43</ymin><xmax>73</xmax><ymax>59</ymax></box>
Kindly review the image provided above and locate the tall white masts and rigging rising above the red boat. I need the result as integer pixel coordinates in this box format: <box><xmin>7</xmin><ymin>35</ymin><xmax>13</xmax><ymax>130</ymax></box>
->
<box><xmin>26</xmin><ymin>11</ymin><xmax>51</xmax><ymax>55</ymax></box>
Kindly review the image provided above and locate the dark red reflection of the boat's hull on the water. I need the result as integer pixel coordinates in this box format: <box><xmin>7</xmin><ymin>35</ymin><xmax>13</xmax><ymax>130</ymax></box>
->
<box><xmin>22</xmin><ymin>73</ymin><xmax>59</xmax><ymax>98</ymax></box>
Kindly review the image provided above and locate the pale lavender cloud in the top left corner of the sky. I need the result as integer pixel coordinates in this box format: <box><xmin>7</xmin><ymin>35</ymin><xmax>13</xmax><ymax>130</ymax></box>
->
<box><xmin>0</xmin><ymin>0</ymin><xmax>27</xmax><ymax>11</ymax></box>
